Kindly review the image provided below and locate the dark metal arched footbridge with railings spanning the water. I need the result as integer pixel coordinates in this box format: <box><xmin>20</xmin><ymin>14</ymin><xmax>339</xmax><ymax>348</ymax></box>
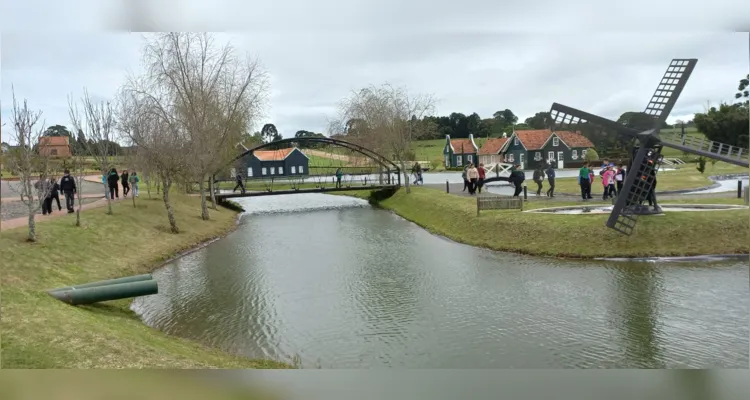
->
<box><xmin>213</xmin><ymin>136</ymin><xmax>401</xmax><ymax>201</ymax></box>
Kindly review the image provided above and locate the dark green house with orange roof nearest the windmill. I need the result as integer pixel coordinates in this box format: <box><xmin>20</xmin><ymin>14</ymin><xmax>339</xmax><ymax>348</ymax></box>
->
<box><xmin>501</xmin><ymin>129</ymin><xmax>594</xmax><ymax>170</ymax></box>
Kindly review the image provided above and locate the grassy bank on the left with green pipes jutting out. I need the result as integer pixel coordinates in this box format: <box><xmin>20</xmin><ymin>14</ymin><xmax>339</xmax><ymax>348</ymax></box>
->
<box><xmin>0</xmin><ymin>195</ymin><xmax>288</xmax><ymax>368</ymax></box>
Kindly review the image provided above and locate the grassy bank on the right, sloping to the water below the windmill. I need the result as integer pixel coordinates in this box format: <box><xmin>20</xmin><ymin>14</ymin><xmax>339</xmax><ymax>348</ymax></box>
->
<box><xmin>342</xmin><ymin>187</ymin><xmax>750</xmax><ymax>258</ymax></box>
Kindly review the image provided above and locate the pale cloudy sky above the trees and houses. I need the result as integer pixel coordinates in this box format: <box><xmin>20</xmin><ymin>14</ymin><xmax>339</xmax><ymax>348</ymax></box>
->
<box><xmin>0</xmin><ymin>0</ymin><xmax>750</xmax><ymax>145</ymax></box>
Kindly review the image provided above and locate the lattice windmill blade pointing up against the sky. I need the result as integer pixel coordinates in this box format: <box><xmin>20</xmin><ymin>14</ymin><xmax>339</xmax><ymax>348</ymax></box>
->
<box><xmin>644</xmin><ymin>58</ymin><xmax>698</xmax><ymax>131</ymax></box>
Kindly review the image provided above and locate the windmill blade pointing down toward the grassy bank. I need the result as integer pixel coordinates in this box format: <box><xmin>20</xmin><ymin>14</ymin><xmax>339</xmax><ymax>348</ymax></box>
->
<box><xmin>607</xmin><ymin>146</ymin><xmax>661</xmax><ymax>236</ymax></box>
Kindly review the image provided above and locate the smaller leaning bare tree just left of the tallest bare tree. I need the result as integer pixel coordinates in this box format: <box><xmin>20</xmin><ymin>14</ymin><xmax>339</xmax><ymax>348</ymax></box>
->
<box><xmin>117</xmin><ymin>86</ymin><xmax>191</xmax><ymax>233</ymax></box>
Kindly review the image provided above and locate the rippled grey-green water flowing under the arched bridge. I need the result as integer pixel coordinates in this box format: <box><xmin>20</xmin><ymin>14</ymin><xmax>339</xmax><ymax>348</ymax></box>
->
<box><xmin>133</xmin><ymin>194</ymin><xmax>750</xmax><ymax>368</ymax></box>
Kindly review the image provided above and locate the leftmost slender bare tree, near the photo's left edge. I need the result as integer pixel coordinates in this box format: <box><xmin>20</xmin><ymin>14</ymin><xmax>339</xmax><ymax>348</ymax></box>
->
<box><xmin>7</xmin><ymin>89</ymin><xmax>51</xmax><ymax>242</ymax></box>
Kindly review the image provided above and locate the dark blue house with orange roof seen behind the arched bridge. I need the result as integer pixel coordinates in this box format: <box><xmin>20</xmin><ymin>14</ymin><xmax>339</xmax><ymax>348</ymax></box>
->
<box><xmin>231</xmin><ymin>147</ymin><xmax>310</xmax><ymax>179</ymax></box>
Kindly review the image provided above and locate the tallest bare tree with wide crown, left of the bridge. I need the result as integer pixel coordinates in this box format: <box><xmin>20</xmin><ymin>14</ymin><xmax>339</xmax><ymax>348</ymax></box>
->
<box><xmin>137</xmin><ymin>32</ymin><xmax>267</xmax><ymax>220</ymax></box>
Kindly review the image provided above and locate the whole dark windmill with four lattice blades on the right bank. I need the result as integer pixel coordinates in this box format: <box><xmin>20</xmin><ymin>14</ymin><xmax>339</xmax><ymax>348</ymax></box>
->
<box><xmin>550</xmin><ymin>58</ymin><xmax>750</xmax><ymax>236</ymax></box>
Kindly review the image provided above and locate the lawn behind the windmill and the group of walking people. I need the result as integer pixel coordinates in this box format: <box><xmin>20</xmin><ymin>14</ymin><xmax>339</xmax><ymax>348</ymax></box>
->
<box><xmin>552</xmin><ymin>162</ymin><xmax>748</xmax><ymax>194</ymax></box>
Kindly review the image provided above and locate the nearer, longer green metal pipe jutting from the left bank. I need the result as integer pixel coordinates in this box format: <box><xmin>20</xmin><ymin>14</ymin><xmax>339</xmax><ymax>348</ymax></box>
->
<box><xmin>49</xmin><ymin>279</ymin><xmax>159</xmax><ymax>305</ymax></box>
